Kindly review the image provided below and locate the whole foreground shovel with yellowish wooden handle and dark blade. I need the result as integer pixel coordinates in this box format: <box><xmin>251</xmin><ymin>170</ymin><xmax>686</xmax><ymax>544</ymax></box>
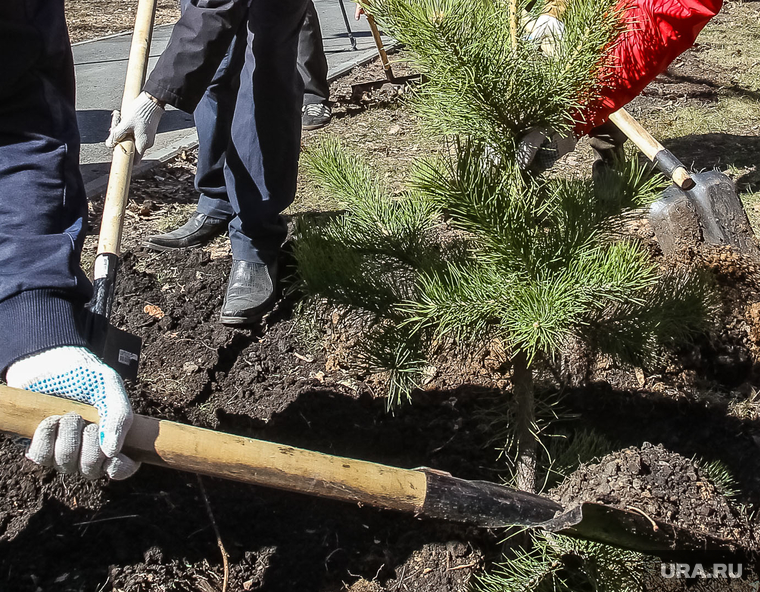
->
<box><xmin>0</xmin><ymin>386</ymin><xmax>748</xmax><ymax>557</ymax></box>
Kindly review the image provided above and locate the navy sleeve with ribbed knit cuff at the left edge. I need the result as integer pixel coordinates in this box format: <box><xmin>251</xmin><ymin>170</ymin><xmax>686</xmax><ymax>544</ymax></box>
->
<box><xmin>0</xmin><ymin>0</ymin><xmax>91</xmax><ymax>373</ymax></box>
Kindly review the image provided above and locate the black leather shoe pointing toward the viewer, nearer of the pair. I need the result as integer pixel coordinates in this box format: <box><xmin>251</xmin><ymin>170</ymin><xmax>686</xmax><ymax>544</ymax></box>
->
<box><xmin>221</xmin><ymin>261</ymin><xmax>277</xmax><ymax>325</ymax></box>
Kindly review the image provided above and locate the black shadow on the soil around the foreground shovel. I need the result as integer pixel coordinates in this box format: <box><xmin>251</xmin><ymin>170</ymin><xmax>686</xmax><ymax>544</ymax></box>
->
<box><xmin>0</xmin><ymin>370</ymin><xmax>760</xmax><ymax>592</ymax></box>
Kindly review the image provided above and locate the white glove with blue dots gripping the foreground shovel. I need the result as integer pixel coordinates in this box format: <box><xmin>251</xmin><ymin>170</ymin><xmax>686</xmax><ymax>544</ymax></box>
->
<box><xmin>6</xmin><ymin>346</ymin><xmax>140</xmax><ymax>479</ymax></box>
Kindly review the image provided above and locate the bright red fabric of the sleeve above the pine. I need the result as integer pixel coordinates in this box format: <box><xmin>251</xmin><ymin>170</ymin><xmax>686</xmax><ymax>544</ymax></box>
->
<box><xmin>576</xmin><ymin>0</ymin><xmax>723</xmax><ymax>135</ymax></box>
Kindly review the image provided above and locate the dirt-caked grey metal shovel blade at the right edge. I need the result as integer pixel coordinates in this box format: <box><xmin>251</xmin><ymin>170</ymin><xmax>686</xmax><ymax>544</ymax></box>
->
<box><xmin>649</xmin><ymin>171</ymin><xmax>760</xmax><ymax>258</ymax></box>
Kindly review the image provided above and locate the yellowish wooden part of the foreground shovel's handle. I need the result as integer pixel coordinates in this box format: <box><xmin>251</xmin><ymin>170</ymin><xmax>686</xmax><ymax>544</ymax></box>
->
<box><xmin>0</xmin><ymin>386</ymin><xmax>427</xmax><ymax>513</ymax></box>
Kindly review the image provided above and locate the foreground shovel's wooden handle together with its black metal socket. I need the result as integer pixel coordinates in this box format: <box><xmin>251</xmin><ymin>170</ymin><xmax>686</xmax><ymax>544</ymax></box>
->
<box><xmin>0</xmin><ymin>385</ymin><xmax>562</xmax><ymax>527</ymax></box>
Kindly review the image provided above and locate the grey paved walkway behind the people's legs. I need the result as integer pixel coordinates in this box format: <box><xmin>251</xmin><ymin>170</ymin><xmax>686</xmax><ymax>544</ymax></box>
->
<box><xmin>75</xmin><ymin>0</ymin><xmax>389</xmax><ymax>196</ymax></box>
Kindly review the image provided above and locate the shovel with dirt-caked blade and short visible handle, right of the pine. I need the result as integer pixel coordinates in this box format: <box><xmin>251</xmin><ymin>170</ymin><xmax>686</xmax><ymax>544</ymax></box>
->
<box><xmin>610</xmin><ymin>109</ymin><xmax>760</xmax><ymax>259</ymax></box>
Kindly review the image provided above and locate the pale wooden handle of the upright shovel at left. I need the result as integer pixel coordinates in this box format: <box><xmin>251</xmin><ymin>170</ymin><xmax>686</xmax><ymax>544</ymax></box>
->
<box><xmin>98</xmin><ymin>0</ymin><xmax>157</xmax><ymax>255</ymax></box>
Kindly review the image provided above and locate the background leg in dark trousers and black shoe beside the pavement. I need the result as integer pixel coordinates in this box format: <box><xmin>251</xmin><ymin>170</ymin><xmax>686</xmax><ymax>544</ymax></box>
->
<box><xmin>298</xmin><ymin>0</ymin><xmax>332</xmax><ymax>130</ymax></box>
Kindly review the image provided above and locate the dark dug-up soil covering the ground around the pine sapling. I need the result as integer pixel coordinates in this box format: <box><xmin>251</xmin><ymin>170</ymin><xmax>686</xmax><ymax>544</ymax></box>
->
<box><xmin>0</xmin><ymin>5</ymin><xmax>760</xmax><ymax>592</ymax></box>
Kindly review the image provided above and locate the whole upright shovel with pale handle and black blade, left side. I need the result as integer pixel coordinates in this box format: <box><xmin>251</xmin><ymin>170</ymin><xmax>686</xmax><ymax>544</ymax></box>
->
<box><xmin>86</xmin><ymin>0</ymin><xmax>156</xmax><ymax>380</ymax></box>
